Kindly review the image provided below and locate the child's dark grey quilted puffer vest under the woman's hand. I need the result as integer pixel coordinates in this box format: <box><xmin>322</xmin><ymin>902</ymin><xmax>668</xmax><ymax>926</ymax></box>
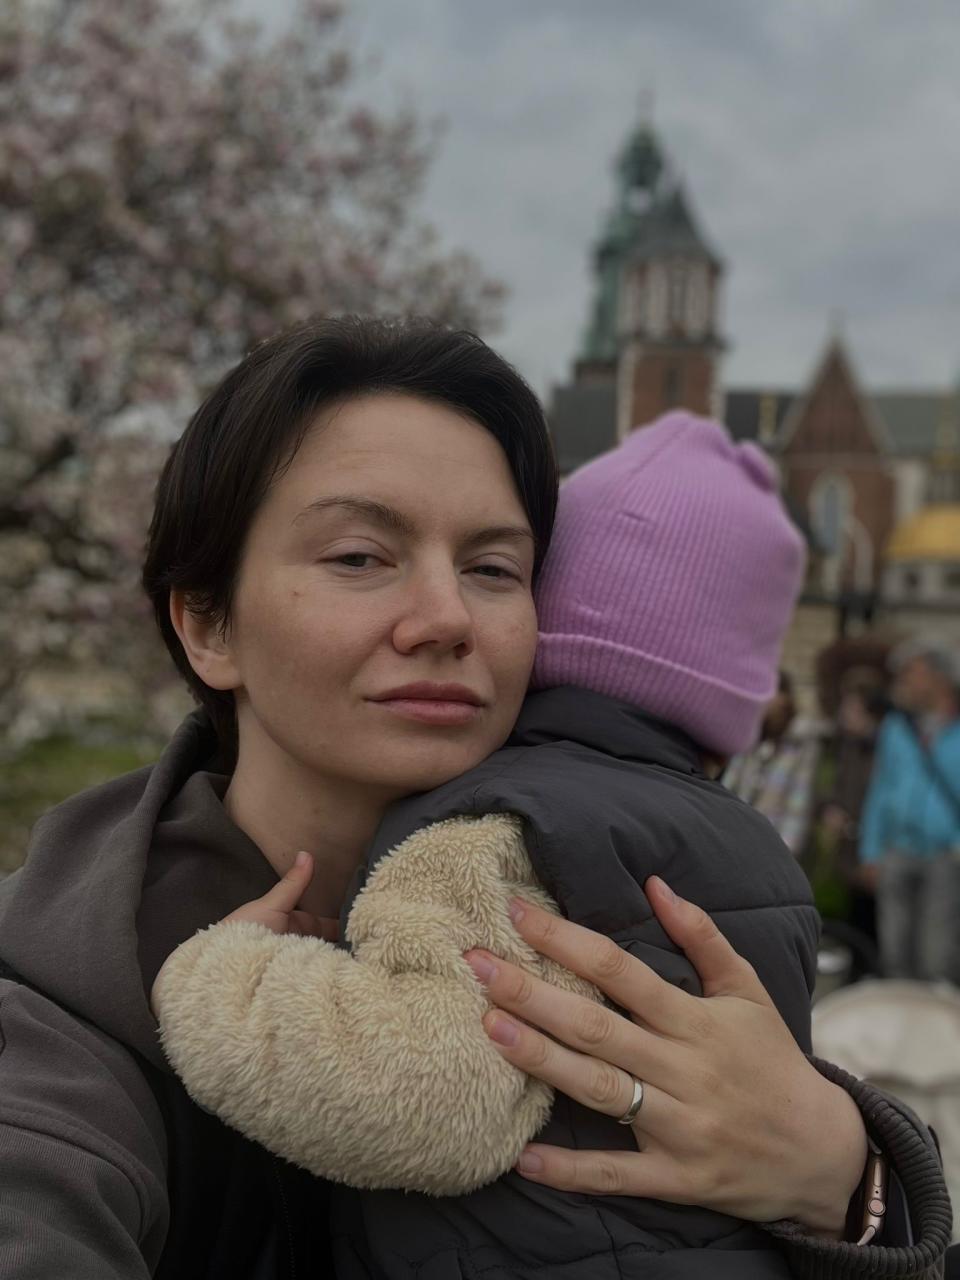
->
<box><xmin>333</xmin><ymin>687</ymin><xmax>819</xmax><ymax>1280</ymax></box>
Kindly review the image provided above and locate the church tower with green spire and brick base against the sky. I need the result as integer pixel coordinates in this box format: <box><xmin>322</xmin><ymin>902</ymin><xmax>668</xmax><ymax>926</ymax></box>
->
<box><xmin>575</xmin><ymin>124</ymin><xmax>724</xmax><ymax>439</ymax></box>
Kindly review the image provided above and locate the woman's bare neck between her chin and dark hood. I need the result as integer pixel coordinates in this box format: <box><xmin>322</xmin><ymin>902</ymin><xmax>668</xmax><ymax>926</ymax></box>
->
<box><xmin>223</xmin><ymin>751</ymin><xmax>396</xmax><ymax>916</ymax></box>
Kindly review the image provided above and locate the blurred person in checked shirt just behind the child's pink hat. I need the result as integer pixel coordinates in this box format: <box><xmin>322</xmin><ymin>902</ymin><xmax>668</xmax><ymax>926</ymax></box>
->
<box><xmin>723</xmin><ymin>671</ymin><xmax>822</xmax><ymax>856</ymax></box>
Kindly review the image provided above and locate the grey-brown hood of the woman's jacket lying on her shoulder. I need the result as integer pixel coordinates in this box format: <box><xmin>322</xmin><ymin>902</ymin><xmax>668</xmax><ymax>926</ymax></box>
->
<box><xmin>0</xmin><ymin>712</ymin><xmax>276</xmax><ymax>1069</ymax></box>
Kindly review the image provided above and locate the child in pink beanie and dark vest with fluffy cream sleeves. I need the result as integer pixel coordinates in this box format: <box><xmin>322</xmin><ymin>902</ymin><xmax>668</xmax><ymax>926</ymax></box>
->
<box><xmin>154</xmin><ymin>412</ymin><xmax>818</xmax><ymax>1280</ymax></box>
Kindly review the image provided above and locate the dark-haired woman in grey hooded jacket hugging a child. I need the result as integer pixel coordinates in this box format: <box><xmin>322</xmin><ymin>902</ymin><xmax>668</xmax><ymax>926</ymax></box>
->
<box><xmin>0</xmin><ymin>314</ymin><xmax>948</xmax><ymax>1280</ymax></box>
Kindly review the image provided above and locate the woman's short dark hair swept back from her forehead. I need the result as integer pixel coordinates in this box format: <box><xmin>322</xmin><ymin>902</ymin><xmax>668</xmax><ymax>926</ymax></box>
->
<box><xmin>142</xmin><ymin>316</ymin><xmax>558</xmax><ymax>758</ymax></box>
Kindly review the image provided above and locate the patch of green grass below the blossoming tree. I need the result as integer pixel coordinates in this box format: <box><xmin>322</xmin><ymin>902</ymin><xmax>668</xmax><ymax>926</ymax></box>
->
<box><xmin>0</xmin><ymin>736</ymin><xmax>159</xmax><ymax>876</ymax></box>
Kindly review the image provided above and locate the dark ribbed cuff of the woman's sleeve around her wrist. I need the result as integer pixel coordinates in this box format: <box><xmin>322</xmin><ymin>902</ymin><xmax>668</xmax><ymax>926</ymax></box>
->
<box><xmin>765</xmin><ymin>1059</ymin><xmax>952</xmax><ymax>1280</ymax></box>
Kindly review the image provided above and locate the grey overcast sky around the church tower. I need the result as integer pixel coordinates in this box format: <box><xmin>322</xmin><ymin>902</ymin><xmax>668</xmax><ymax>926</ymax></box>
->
<box><xmin>252</xmin><ymin>0</ymin><xmax>960</xmax><ymax>392</ymax></box>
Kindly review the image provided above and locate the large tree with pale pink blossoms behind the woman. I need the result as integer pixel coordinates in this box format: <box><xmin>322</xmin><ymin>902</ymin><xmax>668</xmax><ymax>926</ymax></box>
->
<box><xmin>0</xmin><ymin>0</ymin><xmax>500</xmax><ymax>737</ymax></box>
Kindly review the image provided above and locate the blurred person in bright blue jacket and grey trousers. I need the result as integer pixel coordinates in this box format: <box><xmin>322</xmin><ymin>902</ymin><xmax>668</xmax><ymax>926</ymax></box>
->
<box><xmin>860</xmin><ymin>637</ymin><xmax>960</xmax><ymax>983</ymax></box>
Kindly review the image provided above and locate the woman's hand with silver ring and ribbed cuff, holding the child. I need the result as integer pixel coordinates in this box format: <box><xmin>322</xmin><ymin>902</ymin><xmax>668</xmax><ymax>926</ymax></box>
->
<box><xmin>467</xmin><ymin>877</ymin><xmax>950</xmax><ymax>1277</ymax></box>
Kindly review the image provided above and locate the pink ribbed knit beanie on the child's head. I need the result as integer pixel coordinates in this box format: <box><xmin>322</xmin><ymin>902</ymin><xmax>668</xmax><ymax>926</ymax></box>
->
<box><xmin>532</xmin><ymin>412</ymin><xmax>805</xmax><ymax>755</ymax></box>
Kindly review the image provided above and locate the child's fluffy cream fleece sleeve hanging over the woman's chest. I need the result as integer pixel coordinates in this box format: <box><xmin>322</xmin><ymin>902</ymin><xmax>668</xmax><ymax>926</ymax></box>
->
<box><xmin>154</xmin><ymin>815</ymin><xmax>599</xmax><ymax>1196</ymax></box>
